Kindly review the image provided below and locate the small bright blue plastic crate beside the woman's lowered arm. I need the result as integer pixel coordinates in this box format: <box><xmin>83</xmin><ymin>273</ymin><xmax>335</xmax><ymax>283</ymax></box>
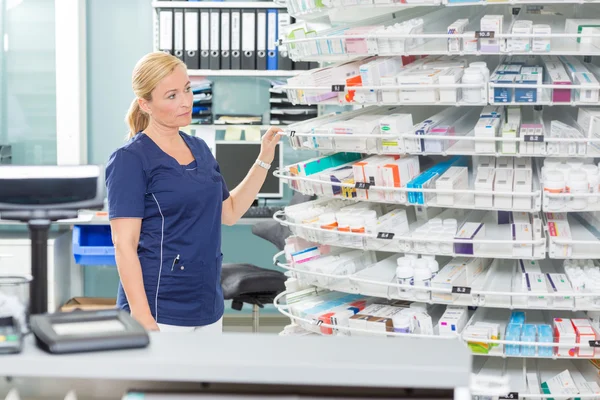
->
<box><xmin>73</xmin><ymin>225</ymin><xmax>117</xmax><ymax>266</ymax></box>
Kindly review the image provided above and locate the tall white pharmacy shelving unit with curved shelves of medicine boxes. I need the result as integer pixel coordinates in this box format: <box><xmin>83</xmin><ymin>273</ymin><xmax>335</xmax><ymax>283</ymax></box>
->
<box><xmin>274</xmin><ymin>0</ymin><xmax>600</xmax><ymax>400</ymax></box>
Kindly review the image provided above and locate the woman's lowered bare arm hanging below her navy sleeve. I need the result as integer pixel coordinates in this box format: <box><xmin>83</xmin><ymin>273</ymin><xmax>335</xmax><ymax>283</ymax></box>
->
<box><xmin>110</xmin><ymin>218</ymin><xmax>159</xmax><ymax>331</ymax></box>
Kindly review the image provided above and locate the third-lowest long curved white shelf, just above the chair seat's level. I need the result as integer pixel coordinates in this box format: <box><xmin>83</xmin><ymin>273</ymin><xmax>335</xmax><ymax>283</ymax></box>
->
<box><xmin>273</xmin><ymin>209</ymin><xmax>548</xmax><ymax>260</ymax></box>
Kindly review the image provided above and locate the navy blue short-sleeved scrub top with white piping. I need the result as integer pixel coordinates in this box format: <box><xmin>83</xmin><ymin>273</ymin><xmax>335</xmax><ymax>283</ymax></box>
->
<box><xmin>106</xmin><ymin>132</ymin><xmax>229</xmax><ymax>326</ymax></box>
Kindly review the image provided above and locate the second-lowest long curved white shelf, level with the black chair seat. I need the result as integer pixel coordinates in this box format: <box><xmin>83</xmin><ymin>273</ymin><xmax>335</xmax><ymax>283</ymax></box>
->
<box><xmin>274</xmin><ymin>252</ymin><xmax>600</xmax><ymax>312</ymax></box>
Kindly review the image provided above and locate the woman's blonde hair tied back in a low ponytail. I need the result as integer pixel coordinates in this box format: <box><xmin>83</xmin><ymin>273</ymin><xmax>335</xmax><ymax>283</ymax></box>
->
<box><xmin>125</xmin><ymin>51</ymin><xmax>185</xmax><ymax>139</ymax></box>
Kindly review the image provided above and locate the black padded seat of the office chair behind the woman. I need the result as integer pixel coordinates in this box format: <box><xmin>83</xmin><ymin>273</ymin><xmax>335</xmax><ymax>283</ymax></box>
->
<box><xmin>221</xmin><ymin>264</ymin><xmax>286</xmax><ymax>310</ymax></box>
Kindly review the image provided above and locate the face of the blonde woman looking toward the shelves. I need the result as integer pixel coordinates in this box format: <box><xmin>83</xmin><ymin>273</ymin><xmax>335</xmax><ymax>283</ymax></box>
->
<box><xmin>146</xmin><ymin>66</ymin><xmax>194</xmax><ymax>128</ymax></box>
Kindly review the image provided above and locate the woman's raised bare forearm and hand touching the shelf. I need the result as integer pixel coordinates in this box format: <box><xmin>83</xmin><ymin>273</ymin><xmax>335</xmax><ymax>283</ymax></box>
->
<box><xmin>221</xmin><ymin>127</ymin><xmax>282</xmax><ymax>226</ymax></box>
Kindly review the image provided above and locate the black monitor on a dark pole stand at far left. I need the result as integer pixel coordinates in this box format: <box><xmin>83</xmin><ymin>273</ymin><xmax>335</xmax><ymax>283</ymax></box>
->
<box><xmin>0</xmin><ymin>165</ymin><xmax>105</xmax><ymax>314</ymax></box>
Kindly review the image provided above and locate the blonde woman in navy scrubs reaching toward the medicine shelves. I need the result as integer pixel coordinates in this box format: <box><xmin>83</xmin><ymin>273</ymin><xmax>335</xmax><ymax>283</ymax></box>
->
<box><xmin>106</xmin><ymin>52</ymin><xmax>280</xmax><ymax>331</ymax></box>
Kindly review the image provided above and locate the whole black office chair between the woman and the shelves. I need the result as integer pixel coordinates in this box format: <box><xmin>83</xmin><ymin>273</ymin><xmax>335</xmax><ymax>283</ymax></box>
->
<box><xmin>221</xmin><ymin>193</ymin><xmax>312</xmax><ymax>333</ymax></box>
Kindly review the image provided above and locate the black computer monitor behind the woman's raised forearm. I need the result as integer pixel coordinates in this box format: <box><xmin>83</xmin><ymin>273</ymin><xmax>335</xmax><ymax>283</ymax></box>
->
<box><xmin>215</xmin><ymin>140</ymin><xmax>283</xmax><ymax>199</ymax></box>
